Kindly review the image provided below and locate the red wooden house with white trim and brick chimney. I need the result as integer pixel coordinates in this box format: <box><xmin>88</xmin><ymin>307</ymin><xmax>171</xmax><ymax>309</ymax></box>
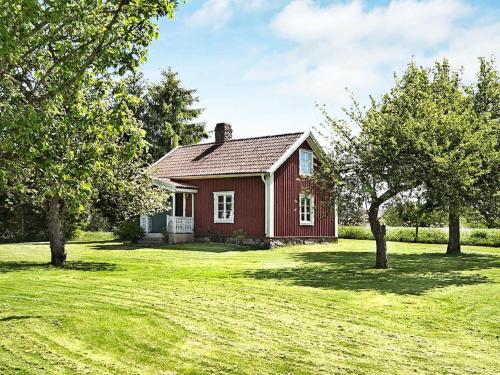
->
<box><xmin>141</xmin><ymin>123</ymin><xmax>338</xmax><ymax>247</ymax></box>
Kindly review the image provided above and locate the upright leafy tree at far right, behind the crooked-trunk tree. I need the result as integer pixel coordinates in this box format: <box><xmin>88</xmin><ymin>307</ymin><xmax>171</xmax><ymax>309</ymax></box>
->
<box><xmin>422</xmin><ymin>60</ymin><xmax>498</xmax><ymax>255</ymax></box>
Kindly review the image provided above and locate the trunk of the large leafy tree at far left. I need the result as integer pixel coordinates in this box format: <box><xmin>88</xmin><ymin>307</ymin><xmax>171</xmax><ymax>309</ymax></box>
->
<box><xmin>49</xmin><ymin>198</ymin><xmax>66</xmax><ymax>267</ymax></box>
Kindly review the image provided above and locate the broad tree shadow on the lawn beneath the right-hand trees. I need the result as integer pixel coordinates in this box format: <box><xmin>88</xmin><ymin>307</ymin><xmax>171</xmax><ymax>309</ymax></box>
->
<box><xmin>247</xmin><ymin>251</ymin><xmax>500</xmax><ymax>295</ymax></box>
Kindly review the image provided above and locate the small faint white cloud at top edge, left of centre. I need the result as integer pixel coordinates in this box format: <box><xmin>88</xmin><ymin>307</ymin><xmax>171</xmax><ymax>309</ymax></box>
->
<box><xmin>188</xmin><ymin>0</ymin><xmax>266</xmax><ymax>28</ymax></box>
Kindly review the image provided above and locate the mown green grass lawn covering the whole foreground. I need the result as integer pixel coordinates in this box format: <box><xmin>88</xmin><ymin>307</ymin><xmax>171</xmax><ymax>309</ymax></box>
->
<box><xmin>0</xmin><ymin>240</ymin><xmax>500</xmax><ymax>374</ymax></box>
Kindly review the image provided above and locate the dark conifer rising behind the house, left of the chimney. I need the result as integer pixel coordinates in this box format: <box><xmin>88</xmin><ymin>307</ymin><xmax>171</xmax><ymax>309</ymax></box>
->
<box><xmin>128</xmin><ymin>68</ymin><xmax>207</xmax><ymax>160</ymax></box>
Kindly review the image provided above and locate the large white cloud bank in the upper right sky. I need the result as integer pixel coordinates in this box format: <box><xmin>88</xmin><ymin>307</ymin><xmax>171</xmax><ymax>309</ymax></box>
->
<box><xmin>245</xmin><ymin>0</ymin><xmax>500</xmax><ymax>106</ymax></box>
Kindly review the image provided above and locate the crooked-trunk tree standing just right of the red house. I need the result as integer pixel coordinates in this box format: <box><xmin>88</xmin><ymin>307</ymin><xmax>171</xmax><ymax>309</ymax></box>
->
<box><xmin>312</xmin><ymin>64</ymin><xmax>429</xmax><ymax>268</ymax></box>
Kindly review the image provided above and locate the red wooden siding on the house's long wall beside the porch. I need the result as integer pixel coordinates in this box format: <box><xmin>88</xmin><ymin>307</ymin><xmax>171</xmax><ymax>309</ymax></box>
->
<box><xmin>184</xmin><ymin>177</ymin><xmax>265</xmax><ymax>237</ymax></box>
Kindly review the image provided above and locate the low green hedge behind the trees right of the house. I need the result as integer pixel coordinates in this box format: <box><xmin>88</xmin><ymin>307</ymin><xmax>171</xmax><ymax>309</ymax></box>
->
<box><xmin>339</xmin><ymin>226</ymin><xmax>500</xmax><ymax>247</ymax></box>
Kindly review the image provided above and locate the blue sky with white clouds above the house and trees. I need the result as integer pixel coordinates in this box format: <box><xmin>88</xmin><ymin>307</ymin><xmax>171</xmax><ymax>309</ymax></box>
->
<box><xmin>141</xmin><ymin>0</ymin><xmax>500</xmax><ymax>138</ymax></box>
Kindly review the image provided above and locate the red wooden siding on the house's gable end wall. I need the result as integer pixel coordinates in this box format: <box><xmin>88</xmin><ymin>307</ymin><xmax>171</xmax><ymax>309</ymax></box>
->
<box><xmin>274</xmin><ymin>142</ymin><xmax>335</xmax><ymax>237</ymax></box>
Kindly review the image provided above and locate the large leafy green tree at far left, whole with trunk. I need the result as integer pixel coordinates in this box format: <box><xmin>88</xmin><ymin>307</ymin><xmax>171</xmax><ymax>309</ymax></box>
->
<box><xmin>0</xmin><ymin>0</ymin><xmax>177</xmax><ymax>266</ymax></box>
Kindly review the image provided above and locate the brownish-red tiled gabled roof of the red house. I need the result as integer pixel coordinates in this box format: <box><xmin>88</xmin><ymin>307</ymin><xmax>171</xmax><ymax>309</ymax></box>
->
<box><xmin>152</xmin><ymin>132</ymin><xmax>318</xmax><ymax>179</ymax></box>
